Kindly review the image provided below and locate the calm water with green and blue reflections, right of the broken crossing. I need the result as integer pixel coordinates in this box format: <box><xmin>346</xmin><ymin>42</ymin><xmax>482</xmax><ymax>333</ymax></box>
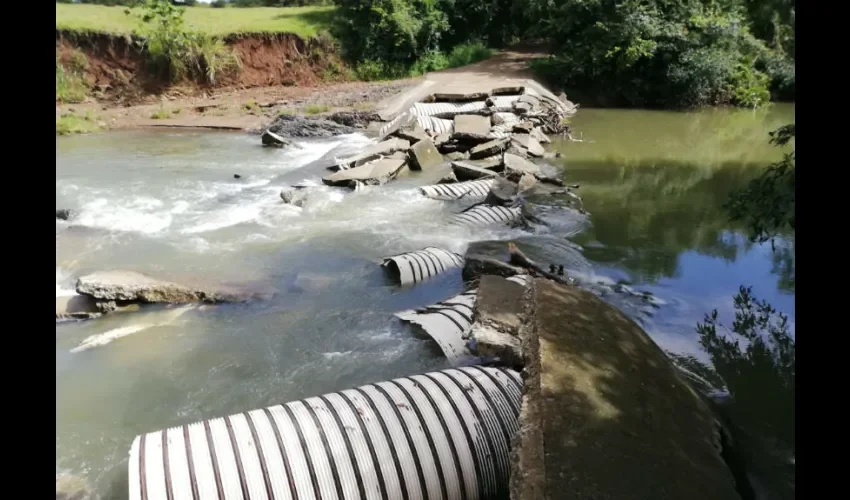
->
<box><xmin>557</xmin><ymin>105</ymin><xmax>796</xmax><ymax>498</ymax></box>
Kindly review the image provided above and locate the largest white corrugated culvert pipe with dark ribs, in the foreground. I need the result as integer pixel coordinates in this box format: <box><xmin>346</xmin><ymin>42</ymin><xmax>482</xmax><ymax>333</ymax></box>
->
<box><xmin>129</xmin><ymin>366</ymin><xmax>522</xmax><ymax>500</ymax></box>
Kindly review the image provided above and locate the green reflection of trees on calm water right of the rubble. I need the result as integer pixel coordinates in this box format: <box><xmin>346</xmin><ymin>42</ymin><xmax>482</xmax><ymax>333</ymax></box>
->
<box><xmin>556</xmin><ymin>105</ymin><xmax>793</xmax><ymax>290</ymax></box>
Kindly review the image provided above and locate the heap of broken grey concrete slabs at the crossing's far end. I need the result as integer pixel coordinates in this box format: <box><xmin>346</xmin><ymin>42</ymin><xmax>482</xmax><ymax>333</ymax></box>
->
<box><xmin>282</xmin><ymin>83</ymin><xmax>576</xmax><ymax>205</ymax></box>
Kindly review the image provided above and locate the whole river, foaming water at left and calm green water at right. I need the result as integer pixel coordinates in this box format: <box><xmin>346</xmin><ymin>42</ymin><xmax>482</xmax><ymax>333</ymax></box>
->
<box><xmin>56</xmin><ymin>105</ymin><xmax>794</xmax><ymax>499</ymax></box>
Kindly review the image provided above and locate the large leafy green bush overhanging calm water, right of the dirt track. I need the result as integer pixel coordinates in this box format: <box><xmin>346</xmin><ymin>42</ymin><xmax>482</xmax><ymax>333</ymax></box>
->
<box><xmin>524</xmin><ymin>0</ymin><xmax>788</xmax><ymax>108</ymax></box>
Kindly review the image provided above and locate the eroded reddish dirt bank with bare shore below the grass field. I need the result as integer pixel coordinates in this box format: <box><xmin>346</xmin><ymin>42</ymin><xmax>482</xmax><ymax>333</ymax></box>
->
<box><xmin>56</xmin><ymin>30</ymin><xmax>415</xmax><ymax>130</ymax></box>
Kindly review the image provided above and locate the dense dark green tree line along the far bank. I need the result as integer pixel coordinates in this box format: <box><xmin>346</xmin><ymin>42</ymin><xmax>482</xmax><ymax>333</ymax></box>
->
<box><xmin>334</xmin><ymin>0</ymin><xmax>795</xmax><ymax>107</ymax></box>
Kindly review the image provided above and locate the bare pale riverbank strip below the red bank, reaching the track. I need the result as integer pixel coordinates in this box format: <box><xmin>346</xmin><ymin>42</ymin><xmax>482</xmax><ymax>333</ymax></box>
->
<box><xmin>56</xmin><ymin>51</ymin><xmax>540</xmax><ymax>131</ymax></box>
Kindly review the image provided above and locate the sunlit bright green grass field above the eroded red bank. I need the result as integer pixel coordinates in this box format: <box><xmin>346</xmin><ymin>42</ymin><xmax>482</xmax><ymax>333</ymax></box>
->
<box><xmin>56</xmin><ymin>3</ymin><xmax>334</xmax><ymax>38</ymax></box>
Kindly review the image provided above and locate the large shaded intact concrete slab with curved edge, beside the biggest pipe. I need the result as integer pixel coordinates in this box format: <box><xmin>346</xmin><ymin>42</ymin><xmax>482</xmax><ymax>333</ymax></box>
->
<box><xmin>528</xmin><ymin>279</ymin><xmax>740</xmax><ymax>500</ymax></box>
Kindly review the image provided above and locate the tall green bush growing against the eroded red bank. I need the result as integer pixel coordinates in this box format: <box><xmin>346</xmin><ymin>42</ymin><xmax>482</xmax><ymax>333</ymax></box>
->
<box><xmin>127</xmin><ymin>0</ymin><xmax>240</xmax><ymax>84</ymax></box>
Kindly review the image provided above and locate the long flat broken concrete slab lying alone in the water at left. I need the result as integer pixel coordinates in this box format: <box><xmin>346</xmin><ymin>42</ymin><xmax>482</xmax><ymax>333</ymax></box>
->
<box><xmin>76</xmin><ymin>270</ymin><xmax>251</xmax><ymax>304</ymax></box>
